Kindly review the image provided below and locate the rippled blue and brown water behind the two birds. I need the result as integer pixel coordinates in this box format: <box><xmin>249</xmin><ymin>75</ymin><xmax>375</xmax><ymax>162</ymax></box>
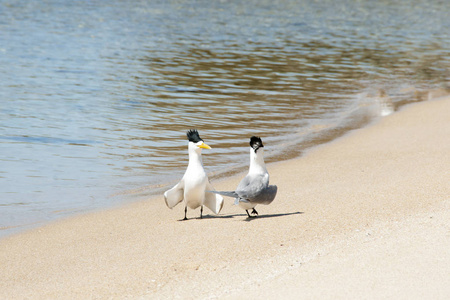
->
<box><xmin>0</xmin><ymin>0</ymin><xmax>450</xmax><ymax>235</ymax></box>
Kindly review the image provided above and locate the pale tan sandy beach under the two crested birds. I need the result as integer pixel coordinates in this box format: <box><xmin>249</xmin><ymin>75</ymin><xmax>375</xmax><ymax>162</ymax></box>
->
<box><xmin>0</xmin><ymin>97</ymin><xmax>450</xmax><ymax>299</ymax></box>
